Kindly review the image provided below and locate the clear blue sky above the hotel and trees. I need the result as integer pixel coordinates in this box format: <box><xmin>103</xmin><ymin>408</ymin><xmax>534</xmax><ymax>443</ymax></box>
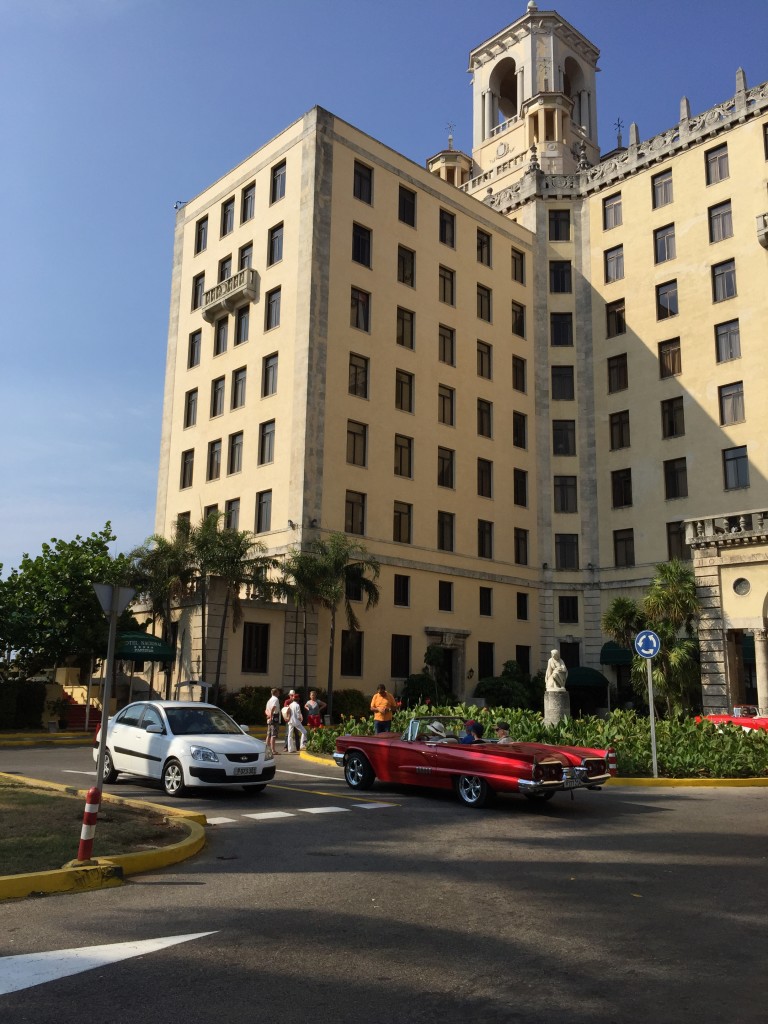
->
<box><xmin>0</xmin><ymin>0</ymin><xmax>768</xmax><ymax>573</ymax></box>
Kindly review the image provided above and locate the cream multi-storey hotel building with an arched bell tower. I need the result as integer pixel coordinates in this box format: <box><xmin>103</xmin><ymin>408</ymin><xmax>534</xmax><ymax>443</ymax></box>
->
<box><xmin>156</xmin><ymin>3</ymin><xmax>768</xmax><ymax>708</ymax></box>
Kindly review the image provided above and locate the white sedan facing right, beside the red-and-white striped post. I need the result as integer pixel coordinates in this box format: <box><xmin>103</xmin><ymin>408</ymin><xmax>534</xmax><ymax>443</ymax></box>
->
<box><xmin>93</xmin><ymin>700</ymin><xmax>274</xmax><ymax>797</ymax></box>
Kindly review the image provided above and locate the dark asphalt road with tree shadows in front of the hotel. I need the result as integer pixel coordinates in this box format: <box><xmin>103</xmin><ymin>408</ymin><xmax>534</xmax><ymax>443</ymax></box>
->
<box><xmin>0</xmin><ymin>750</ymin><xmax>768</xmax><ymax>1024</ymax></box>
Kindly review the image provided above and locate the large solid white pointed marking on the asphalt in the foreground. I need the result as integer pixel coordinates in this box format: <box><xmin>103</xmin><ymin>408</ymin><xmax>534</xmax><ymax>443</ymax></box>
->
<box><xmin>0</xmin><ymin>932</ymin><xmax>216</xmax><ymax>995</ymax></box>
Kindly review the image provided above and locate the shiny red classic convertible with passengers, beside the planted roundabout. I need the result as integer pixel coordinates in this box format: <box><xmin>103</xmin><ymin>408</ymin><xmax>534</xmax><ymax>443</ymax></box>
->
<box><xmin>334</xmin><ymin>716</ymin><xmax>616</xmax><ymax>807</ymax></box>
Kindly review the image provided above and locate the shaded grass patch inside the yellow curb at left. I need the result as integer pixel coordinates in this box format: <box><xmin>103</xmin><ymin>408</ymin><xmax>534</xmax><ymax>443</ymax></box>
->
<box><xmin>0</xmin><ymin>779</ymin><xmax>186</xmax><ymax>874</ymax></box>
